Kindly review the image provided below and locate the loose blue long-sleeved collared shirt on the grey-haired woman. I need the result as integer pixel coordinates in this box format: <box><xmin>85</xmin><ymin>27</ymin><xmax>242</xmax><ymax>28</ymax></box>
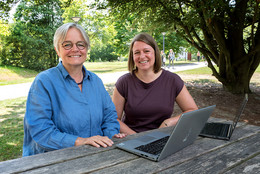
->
<box><xmin>23</xmin><ymin>62</ymin><xmax>120</xmax><ymax>156</ymax></box>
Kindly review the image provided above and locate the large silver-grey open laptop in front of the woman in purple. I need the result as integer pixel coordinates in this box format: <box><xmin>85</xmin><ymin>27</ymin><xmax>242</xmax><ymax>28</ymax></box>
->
<box><xmin>116</xmin><ymin>105</ymin><xmax>216</xmax><ymax>161</ymax></box>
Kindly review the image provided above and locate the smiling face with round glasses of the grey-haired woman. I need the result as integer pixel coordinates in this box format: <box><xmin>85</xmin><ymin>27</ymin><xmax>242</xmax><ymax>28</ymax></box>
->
<box><xmin>58</xmin><ymin>28</ymin><xmax>88</xmax><ymax>68</ymax></box>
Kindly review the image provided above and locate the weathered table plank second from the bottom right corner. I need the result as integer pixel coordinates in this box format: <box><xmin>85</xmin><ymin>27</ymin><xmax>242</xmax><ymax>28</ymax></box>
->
<box><xmin>158</xmin><ymin>133</ymin><xmax>260</xmax><ymax>174</ymax></box>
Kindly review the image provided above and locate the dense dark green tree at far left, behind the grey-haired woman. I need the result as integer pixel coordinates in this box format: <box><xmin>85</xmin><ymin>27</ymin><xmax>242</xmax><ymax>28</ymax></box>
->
<box><xmin>1</xmin><ymin>0</ymin><xmax>62</xmax><ymax>70</ymax></box>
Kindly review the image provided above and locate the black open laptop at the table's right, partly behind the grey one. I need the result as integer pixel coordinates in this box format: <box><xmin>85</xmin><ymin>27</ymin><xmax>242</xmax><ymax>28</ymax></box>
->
<box><xmin>200</xmin><ymin>94</ymin><xmax>248</xmax><ymax>140</ymax></box>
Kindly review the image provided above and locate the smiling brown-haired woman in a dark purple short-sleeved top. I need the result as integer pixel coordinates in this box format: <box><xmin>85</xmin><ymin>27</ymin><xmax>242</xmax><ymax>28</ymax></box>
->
<box><xmin>112</xmin><ymin>33</ymin><xmax>198</xmax><ymax>134</ymax></box>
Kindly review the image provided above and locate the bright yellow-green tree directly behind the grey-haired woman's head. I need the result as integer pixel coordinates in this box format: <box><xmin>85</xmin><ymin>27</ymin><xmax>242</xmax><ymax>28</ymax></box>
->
<box><xmin>63</xmin><ymin>0</ymin><xmax>118</xmax><ymax>61</ymax></box>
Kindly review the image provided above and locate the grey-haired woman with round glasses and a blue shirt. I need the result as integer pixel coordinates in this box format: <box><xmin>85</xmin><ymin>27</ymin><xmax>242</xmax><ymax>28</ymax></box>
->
<box><xmin>23</xmin><ymin>23</ymin><xmax>125</xmax><ymax>156</ymax></box>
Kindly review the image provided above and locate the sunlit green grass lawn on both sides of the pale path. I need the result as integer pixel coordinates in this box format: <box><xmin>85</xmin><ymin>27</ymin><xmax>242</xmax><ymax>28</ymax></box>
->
<box><xmin>0</xmin><ymin>61</ymin><xmax>260</xmax><ymax>161</ymax></box>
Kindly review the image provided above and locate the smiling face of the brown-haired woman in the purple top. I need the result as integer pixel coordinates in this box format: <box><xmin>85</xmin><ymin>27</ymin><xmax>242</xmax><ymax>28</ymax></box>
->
<box><xmin>133</xmin><ymin>41</ymin><xmax>155</xmax><ymax>71</ymax></box>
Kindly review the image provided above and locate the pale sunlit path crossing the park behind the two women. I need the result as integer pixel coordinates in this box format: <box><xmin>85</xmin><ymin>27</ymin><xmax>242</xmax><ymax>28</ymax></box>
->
<box><xmin>0</xmin><ymin>62</ymin><xmax>206</xmax><ymax>101</ymax></box>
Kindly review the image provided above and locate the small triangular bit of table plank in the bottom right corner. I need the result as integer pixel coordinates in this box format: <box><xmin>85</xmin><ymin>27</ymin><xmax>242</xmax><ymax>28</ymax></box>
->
<box><xmin>226</xmin><ymin>154</ymin><xmax>260</xmax><ymax>174</ymax></box>
